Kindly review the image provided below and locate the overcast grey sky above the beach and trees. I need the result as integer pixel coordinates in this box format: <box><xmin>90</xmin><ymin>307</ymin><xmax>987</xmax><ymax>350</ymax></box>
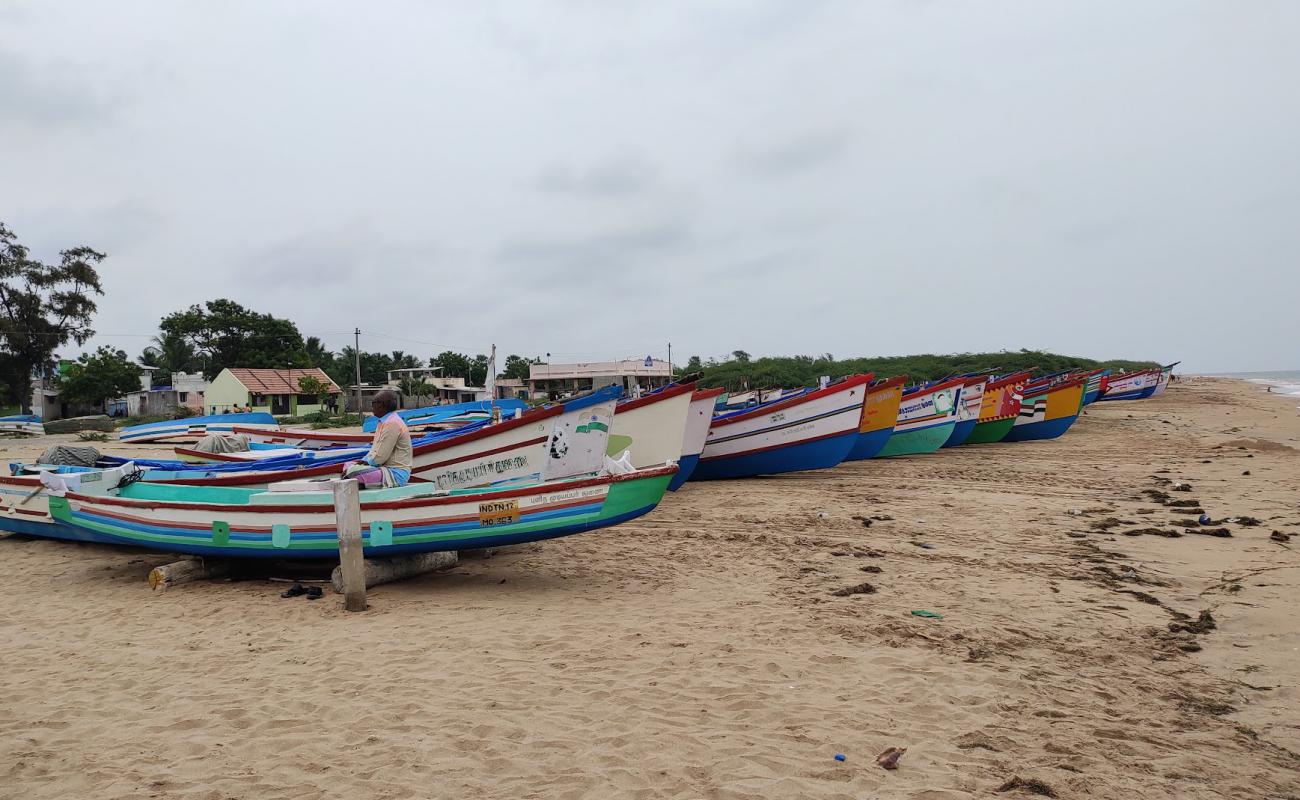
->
<box><xmin>0</xmin><ymin>0</ymin><xmax>1300</xmax><ymax>371</ymax></box>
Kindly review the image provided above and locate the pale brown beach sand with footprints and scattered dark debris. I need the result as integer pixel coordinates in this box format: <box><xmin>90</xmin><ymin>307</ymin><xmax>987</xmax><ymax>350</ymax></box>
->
<box><xmin>0</xmin><ymin>379</ymin><xmax>1300</xmax><ymax>800</ymax></box>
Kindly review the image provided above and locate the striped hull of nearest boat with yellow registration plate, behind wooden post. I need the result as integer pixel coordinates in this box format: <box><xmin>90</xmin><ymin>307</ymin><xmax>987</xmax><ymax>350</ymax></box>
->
<box><xmin>49</xmin><ymin>464</ymin><xmax>676</xmax><ymax>559</ymax></box>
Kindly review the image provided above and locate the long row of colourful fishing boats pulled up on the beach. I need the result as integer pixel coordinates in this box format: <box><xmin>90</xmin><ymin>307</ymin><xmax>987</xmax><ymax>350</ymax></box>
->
<box><xmin>0</xmin><ymin>366</ymin><xmax>1173</xmax><ymax>558</ymax></box>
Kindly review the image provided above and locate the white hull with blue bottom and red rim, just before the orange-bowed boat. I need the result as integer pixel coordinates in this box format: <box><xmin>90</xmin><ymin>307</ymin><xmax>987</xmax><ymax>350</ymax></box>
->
<box><xmin>692</xmin><ymin>375</ymin><xmax>871</xmax><ymax>480</ymax></box>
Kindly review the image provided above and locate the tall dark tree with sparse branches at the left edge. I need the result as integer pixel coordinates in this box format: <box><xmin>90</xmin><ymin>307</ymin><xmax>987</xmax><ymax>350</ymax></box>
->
<box><xmin>0</xmin><ymin>222</ymin><xmax>105</xmax><ymax>410</ymax></box>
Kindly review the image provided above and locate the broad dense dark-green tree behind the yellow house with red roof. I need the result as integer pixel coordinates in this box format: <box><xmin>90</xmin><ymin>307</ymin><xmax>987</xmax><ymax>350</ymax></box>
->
<box><xmin>159</xmin><ymin>299</ymin><xmax>311</xmax><ymax>379</ymax></box>
